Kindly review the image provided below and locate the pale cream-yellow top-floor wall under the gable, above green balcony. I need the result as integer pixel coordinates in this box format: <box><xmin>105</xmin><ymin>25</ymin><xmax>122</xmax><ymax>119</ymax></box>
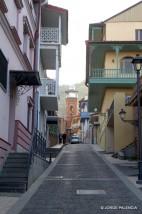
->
<box><xmin>106</xmin><ymin>22</ymin><xmax>142</xmax><ymax>41</ymax></box>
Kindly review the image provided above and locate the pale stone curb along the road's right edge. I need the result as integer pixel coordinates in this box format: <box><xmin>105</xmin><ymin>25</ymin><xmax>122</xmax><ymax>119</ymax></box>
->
<box><xmin>91</xmin><ymin>145</ymin><xmax>142</xmax><ymax>201</ymax></box>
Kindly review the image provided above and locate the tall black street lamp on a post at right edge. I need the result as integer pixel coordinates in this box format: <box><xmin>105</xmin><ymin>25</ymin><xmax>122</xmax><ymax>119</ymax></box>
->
<box><xmin>132</xmin><ymin>56</ymin><xmax>142</xmax><ymax>183</ymax></box>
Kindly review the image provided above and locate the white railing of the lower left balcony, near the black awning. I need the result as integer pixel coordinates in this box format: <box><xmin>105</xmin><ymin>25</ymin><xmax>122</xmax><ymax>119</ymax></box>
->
<box><xmin>40</xmin><ymin>78</ymin><xmax>56</xmax><ymax>96</ymax></box>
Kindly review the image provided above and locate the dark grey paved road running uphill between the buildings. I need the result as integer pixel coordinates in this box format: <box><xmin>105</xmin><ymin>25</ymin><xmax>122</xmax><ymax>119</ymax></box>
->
<box><xmin>11</xmin><ymin>145</ymin><xmax>142</xmax><ymax>214</ymax></box>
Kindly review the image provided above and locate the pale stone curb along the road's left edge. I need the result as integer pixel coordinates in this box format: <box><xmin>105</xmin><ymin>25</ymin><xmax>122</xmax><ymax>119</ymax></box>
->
<box><xmin>6</xmin><ymin>145</ymin><xmax>64</xmax><ymax>214</ymax></box>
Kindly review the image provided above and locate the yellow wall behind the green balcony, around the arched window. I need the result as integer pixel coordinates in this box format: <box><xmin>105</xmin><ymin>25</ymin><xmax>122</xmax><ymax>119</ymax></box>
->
<box><xmin>105</xmin><ymin>50</ymin><xmax>142</xmax><ymax>69</ymax></box>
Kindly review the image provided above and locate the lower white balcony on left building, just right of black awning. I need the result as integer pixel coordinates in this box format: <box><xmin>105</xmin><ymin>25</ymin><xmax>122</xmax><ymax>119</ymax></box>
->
<box><xmin>40</xmin><ymin>78</ymin><xmax>58</xmax><ymax>111</ymax></box>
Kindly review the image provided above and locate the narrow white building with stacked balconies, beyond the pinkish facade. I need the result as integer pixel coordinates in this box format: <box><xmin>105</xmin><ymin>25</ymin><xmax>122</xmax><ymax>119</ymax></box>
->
<box><xmin>38</xmin><ymin>4</ymin><xmax>68</xmax><ymax>146</ymax></box>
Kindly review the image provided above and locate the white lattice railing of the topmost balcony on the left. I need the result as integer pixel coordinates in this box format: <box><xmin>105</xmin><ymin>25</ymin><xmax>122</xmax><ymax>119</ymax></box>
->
<box><xmin>40</xmin><ymin>27</ymin><xmax>59</xmax><ymax>43</ymax></box>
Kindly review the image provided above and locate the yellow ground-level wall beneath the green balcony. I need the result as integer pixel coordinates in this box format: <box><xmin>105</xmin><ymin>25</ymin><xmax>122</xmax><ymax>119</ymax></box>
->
<box><xmin>98</xmin><ymin>92</ymin><xmax>136</xmax><ymax>152</ymax></box>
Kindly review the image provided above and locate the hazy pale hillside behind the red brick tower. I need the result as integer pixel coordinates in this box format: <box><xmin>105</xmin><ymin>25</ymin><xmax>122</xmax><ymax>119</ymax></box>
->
<box><xmin>58</xmin><ymin>82</ymin><xmax>88</xmax><ymax>116</ymax></box>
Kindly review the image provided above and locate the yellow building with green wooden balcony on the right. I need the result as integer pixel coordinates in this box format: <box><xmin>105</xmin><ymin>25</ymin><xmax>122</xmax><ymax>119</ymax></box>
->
<box><xmin>86</xmin><ymin>2</ymin><xmax>142</xmax><ymax>155</ymax></box>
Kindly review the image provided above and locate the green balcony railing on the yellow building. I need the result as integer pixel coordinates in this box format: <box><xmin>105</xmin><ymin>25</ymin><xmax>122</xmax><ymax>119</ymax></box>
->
<box><xmin>90</xmin><ymin>68</ymin><xmax>139</xmax><ymax>79</ymax></box>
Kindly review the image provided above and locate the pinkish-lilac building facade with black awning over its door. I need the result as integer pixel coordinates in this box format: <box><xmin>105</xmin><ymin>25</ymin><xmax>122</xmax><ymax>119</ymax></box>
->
<box><xmin>0</xmin><ymin>0</ymin><xmax>41</xmax><ymax>167</ymax></box>
